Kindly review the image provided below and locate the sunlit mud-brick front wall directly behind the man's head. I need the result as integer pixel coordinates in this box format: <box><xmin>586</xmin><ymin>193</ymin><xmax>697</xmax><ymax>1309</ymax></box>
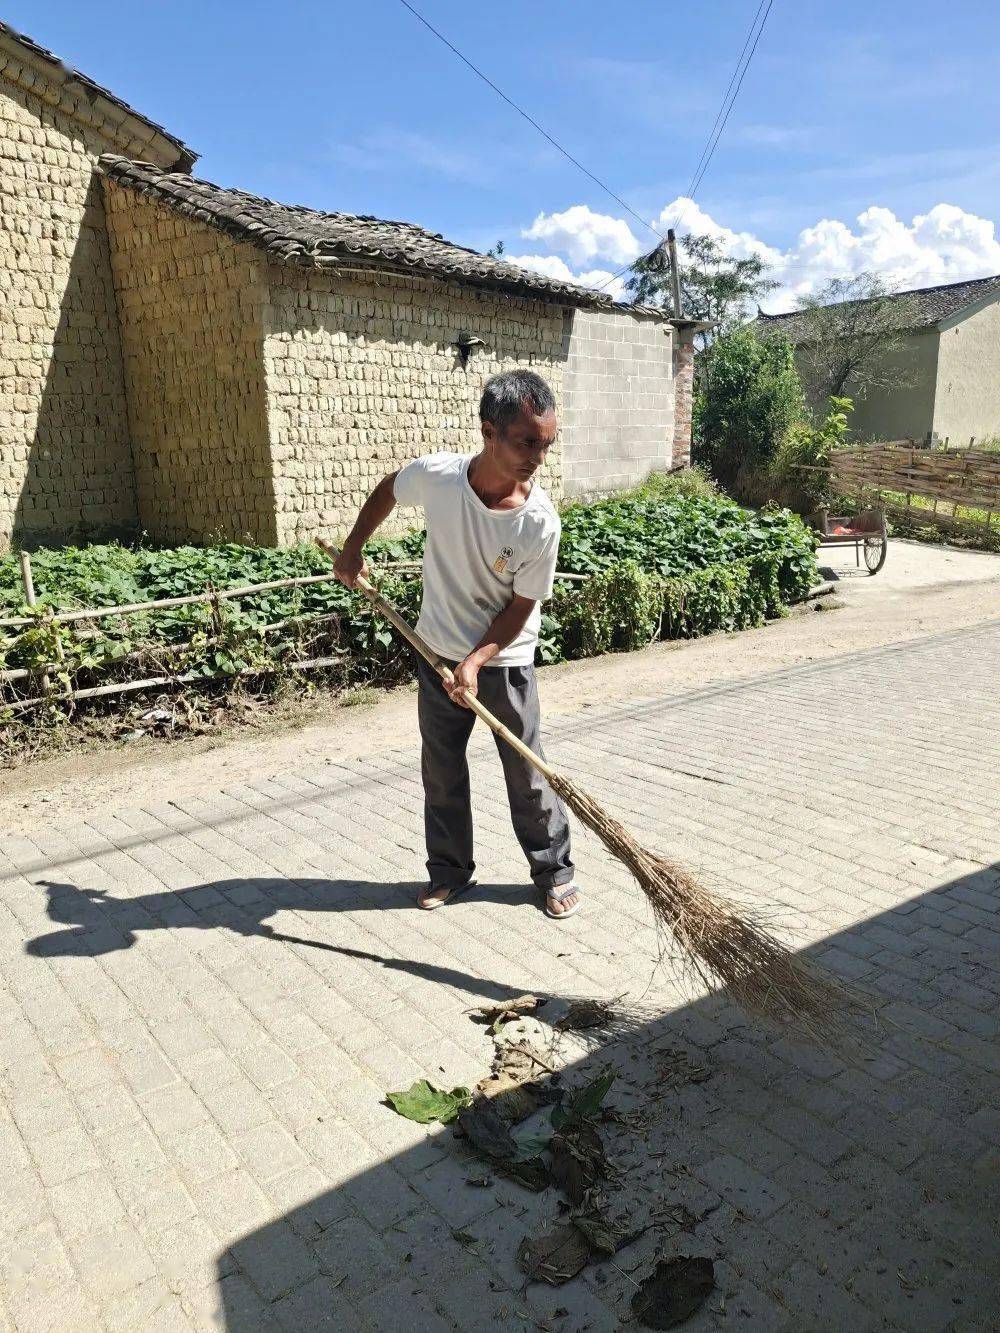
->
<box><xmin>264</xmin><ymin>265</ymin><xmax>565</xmax><ymax>543</ymax></box>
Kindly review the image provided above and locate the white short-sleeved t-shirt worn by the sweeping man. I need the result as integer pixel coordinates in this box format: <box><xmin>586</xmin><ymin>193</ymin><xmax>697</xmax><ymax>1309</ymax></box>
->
<box><xmin>393</xmin><ymin>453</ymin><xmax>560</xmax><ymax>667</ymax></box>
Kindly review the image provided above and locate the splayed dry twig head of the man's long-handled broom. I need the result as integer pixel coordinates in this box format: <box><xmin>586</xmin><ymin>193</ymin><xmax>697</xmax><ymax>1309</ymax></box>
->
<box><xmin>551</xmin><ymin>773</ymin><xmax>855</xmax><ymax>1038</ymax></box>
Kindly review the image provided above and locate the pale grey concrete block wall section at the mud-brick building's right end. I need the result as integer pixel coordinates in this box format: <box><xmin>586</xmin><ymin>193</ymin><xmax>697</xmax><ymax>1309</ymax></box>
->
<box><xmin>563</xmin><ymin>311</ymin><xmax>673</xmax><ymax>497</ymax></box>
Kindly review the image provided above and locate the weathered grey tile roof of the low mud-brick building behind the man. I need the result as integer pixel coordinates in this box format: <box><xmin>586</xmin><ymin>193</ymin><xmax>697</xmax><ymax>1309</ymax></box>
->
<box><xmin>99</xmin><ymin>156</ymin><xmax>665</xmax><ymax>313</ymax></box>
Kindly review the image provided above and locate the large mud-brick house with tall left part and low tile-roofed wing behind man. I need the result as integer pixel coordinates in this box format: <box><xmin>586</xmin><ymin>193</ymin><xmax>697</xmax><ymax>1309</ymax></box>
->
<box><xmin>0</xmin><ymin>16</ymin><xmax>700</xmax><ymax>547</ymax></box>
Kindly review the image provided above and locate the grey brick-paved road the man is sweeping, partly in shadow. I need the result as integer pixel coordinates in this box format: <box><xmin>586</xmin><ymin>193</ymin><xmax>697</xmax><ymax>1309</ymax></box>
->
<box><xmin>0</xmin><ymin>625</ymin><xmax>1000</xmax><ymax>1333</ymax></box>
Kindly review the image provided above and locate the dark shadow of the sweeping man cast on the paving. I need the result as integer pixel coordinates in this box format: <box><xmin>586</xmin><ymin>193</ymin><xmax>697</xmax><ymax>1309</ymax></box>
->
<box><xmin>25</xmin><ymin>878</ymin><xmax>541</xmax><ymax>1000</ymax></box>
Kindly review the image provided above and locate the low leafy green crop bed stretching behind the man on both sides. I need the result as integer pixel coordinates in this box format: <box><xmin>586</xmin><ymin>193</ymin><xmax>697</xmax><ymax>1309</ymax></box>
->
<box><xmin>0</xmin><ymin>485</ymin><xmax>816</xmax><ymax>725</ymax></box>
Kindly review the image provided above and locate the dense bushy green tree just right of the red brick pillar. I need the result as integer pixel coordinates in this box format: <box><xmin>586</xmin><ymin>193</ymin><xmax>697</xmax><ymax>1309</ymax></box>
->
<box><xmin>693</xmin><ymin>325</ymin><xmax>805</xmax><ymax>492</ymax></box>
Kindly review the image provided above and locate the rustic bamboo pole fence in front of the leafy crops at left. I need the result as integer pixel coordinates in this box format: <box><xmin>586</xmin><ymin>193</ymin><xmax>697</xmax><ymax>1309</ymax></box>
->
<box><xmin>0</xmin><ymin>551</ymin><xmax>589</xmax><ymax>710</ymax></box>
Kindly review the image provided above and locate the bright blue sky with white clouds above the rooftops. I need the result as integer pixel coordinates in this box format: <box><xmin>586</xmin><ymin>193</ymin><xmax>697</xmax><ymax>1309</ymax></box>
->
<box><xmin>13</xmin><ymin>0</ymin><xmax>1000</xmax><ymax>300</ymax></box>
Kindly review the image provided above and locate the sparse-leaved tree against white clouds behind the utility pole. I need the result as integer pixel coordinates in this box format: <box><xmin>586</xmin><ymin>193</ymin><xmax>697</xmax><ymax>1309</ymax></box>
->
<box><xmin>625</xmin><ymin>235</ymin><xmax>777</xmax><ymax>345</ymax></box>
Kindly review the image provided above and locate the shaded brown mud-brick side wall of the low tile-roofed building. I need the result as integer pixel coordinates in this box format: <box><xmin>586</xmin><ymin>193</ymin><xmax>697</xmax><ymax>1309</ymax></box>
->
<box><xmin>104</xmin><ymin>180</ymin><xmax>276</xmax><ymax>544</ymax></box>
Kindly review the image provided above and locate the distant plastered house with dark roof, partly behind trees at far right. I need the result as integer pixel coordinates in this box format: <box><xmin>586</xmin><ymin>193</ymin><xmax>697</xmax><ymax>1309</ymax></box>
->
<box><xmin>757</xmin><ymin>275</ymin><xmax>1000</xmax><ymax>447</ymax></box>
